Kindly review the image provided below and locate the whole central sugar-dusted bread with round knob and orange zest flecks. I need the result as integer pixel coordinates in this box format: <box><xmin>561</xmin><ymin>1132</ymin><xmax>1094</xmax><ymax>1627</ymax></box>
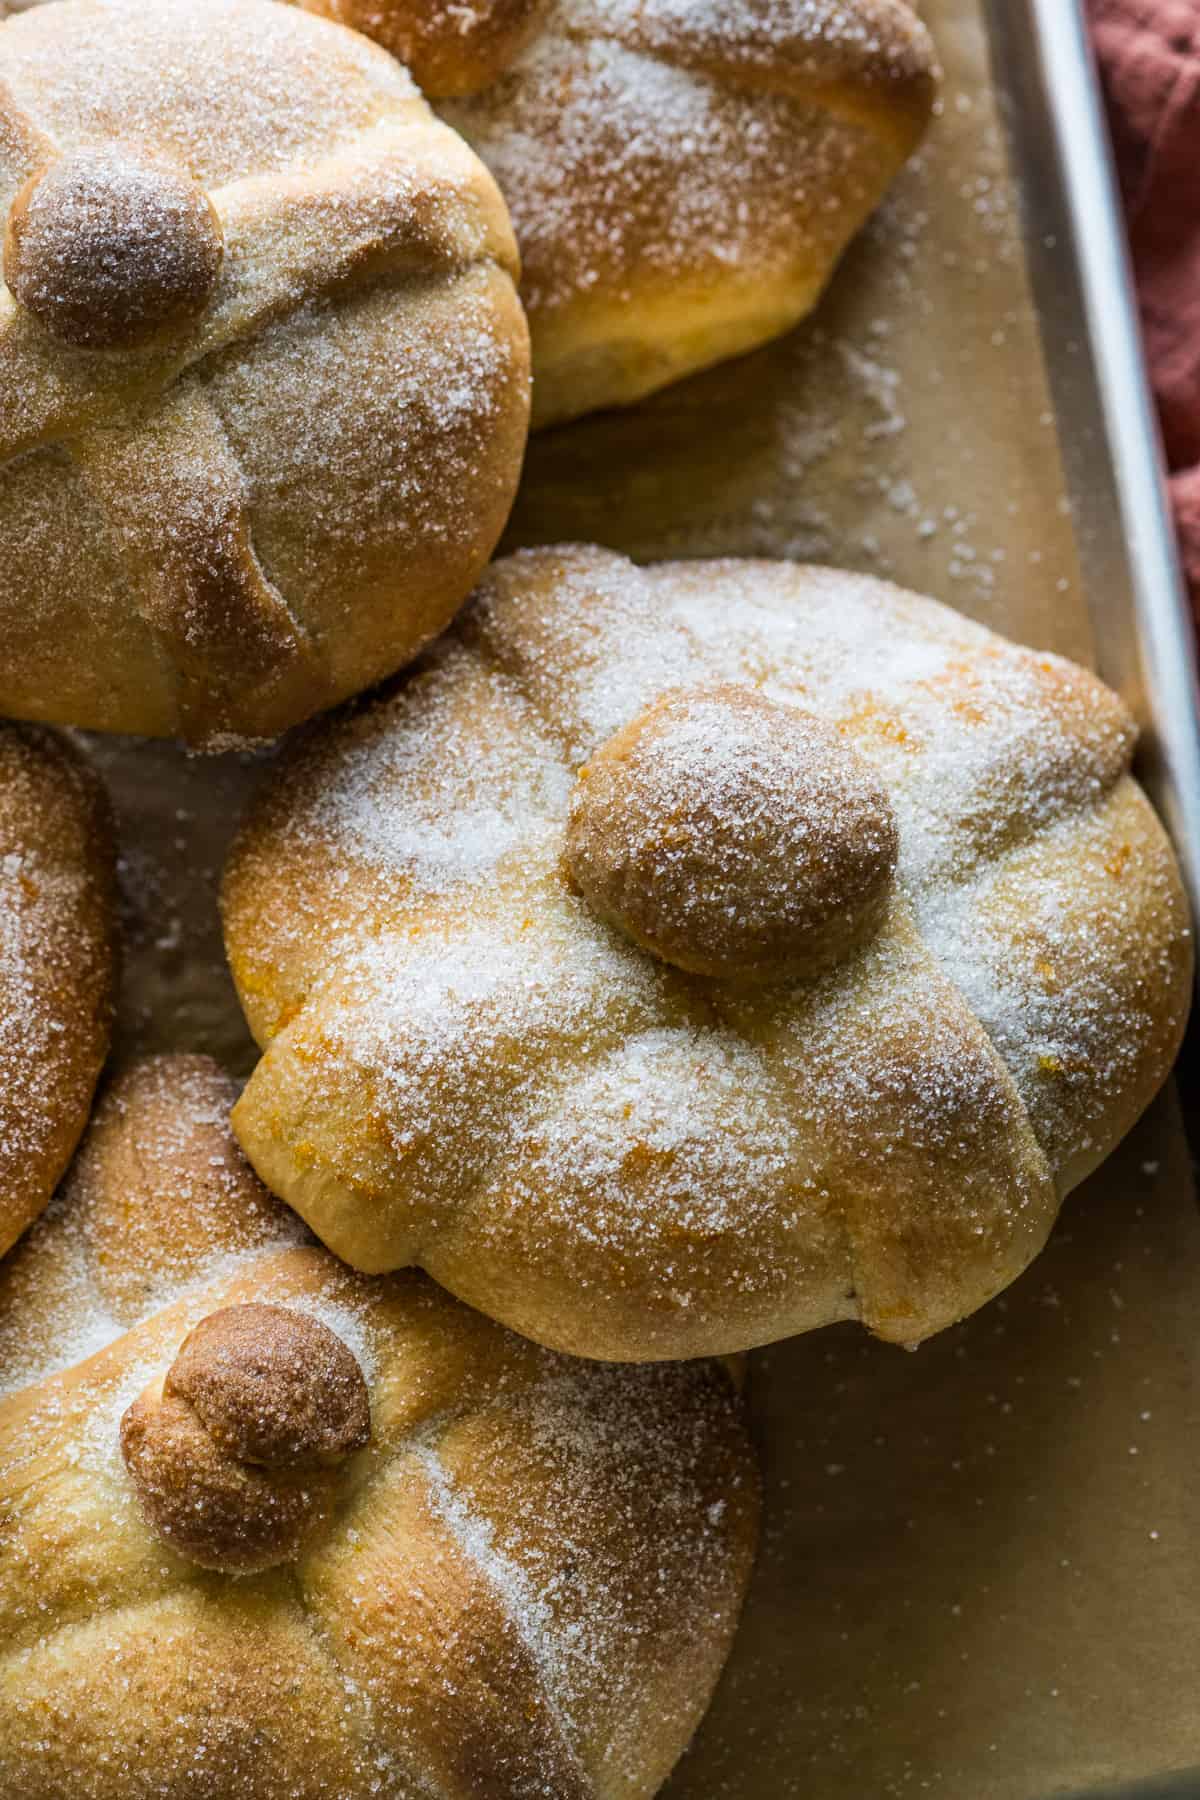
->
<box><xmin>225</xmin><ymin>547</ymin><xmax>1193</xmax><ymax>1361</ymax></box>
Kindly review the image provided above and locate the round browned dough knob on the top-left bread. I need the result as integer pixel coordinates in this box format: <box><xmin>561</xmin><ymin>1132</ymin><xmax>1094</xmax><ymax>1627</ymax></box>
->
<box><xmin>4</xmin><ymin>144</ymin><xmax>223</xmax><ymax>349</ymax></box>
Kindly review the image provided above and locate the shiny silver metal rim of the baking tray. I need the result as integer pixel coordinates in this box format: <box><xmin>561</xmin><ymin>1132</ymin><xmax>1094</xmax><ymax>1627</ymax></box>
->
<box><xmin>984</xmin><ymin>0</ymin><xmax>1200</xmax><ymax>928</ymax></box>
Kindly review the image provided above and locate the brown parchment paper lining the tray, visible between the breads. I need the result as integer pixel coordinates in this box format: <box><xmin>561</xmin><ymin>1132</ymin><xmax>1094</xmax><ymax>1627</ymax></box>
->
<box><xmin>75</xmin><ymin>0</ymin><xmax>1200</xmax><ymax>1800</ymax></box>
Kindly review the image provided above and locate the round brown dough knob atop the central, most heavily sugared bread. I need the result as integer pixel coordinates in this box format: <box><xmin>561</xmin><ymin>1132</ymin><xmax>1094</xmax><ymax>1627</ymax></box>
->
<box><xmin>567</xmin><ymin>686</ymin><xmax>900</xmax><ymax>979</ymax></box>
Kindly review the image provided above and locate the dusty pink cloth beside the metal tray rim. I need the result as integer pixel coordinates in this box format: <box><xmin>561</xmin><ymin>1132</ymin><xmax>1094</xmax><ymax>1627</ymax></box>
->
<box><xmin>1090</xmin><ymin>0</ymin><xmax>1200</xmax><ymax>616</ymax></box>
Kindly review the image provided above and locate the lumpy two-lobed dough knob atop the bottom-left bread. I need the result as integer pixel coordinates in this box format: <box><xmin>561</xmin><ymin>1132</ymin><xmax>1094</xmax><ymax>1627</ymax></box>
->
<box><xmin>121</xmin><ymin>1305</ymin><xmax>371</xmax><ymax>1573</ymax></box>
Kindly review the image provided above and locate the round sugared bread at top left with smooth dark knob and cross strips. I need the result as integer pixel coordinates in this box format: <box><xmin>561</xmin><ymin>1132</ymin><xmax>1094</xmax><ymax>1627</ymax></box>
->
<box><xmin>0</xmin><ymin>0</ymin><xmax>529</xmax><ymax>749</ymax></box>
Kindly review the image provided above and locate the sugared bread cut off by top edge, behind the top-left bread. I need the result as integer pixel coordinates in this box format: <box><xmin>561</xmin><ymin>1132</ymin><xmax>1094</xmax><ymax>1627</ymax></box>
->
<box><xmin>302</xmin><ymin>0</ymin><xmax>937</xmax><ymax>425</ymax></box>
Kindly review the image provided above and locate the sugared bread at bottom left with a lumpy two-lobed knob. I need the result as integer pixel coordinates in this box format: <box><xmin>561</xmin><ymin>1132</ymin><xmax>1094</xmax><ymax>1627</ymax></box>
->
<box><xmin>0</xmin><ymin>1057</ymin><xmax>757</xmax><ymax>1800</ymax></box>
